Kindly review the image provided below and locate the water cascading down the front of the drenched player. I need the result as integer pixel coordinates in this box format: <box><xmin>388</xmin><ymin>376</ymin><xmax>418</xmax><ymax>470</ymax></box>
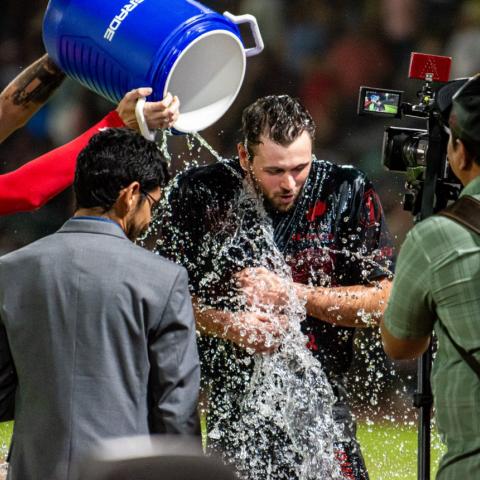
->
<box><xmin>152</xmin><ymin>171</ymin><xmax>343</xmax><ymax>480</ymax></box>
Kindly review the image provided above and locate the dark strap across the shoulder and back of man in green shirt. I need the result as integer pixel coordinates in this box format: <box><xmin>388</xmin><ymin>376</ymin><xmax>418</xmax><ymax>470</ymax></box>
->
<box><xmin>437</xmin><ymin>195</ymin><xmax>480</xmax><ymax>380</ymax></box>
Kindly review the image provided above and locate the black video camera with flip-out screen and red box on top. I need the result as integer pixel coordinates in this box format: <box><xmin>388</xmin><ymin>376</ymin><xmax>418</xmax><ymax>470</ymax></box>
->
<box><xmin>357</xmin><ymin>52</ymin><xmax>461</xmax><ymax>218</ymax></box>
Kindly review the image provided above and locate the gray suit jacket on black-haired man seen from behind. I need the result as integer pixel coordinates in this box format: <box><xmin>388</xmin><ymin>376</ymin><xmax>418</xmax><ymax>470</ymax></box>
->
<box><xmin>0</xmin><ymin>218</ymin><xmax>200</xmax><ymax>480</ymax></box>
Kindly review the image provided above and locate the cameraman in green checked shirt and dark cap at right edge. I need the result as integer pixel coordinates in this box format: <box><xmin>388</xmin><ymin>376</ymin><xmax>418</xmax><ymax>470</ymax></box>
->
<box><xmin>382</xmin><ymin>75</ymin><xmax>480</xmax><ymax>480</ymax></box>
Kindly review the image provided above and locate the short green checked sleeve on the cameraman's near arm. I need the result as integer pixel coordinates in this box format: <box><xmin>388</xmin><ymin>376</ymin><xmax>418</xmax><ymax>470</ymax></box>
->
<box><xmin>385</xmin><ymin>227</ymin><xmax>435</xmax><ymax>339</ymax></box>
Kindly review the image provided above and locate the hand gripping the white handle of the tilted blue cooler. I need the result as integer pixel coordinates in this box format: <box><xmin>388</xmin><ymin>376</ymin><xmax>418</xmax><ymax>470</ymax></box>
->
<box><xmin>116</xmin><ymin>87</ymin><xmax>180</xmax><ymax>130</ymax></box>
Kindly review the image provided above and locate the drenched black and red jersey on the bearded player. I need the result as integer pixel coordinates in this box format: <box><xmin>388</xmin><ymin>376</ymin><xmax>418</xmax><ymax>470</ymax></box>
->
<box><xmin>160</xmin><ymin>160</ymin><xmax>393</xmax><ymax>384</ymax></box>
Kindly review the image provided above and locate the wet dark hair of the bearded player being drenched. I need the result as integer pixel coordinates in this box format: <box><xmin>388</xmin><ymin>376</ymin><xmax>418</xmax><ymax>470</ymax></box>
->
<box><xmin>241</xmin><ymin>95</ymin><xmax>315</xmax><ymax>159</ymax></box>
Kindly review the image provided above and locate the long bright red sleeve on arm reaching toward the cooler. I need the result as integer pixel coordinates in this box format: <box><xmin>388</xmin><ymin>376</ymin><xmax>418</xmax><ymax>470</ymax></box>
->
<box><xmin>0</xmin><ymin>111</ymin><xmax>125</xmax><ymax>215</ymax></box>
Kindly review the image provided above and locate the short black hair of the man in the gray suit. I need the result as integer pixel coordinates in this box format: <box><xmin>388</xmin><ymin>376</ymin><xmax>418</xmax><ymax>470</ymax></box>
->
<box><xmin>73</xmin><ymin>128</ymin><xmax>170</xmax><ymax>212</ymax></box>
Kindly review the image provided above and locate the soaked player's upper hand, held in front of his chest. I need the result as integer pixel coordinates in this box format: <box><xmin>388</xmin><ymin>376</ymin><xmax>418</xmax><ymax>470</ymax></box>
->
<box><xmin>234</xmin><ymin>267</ymin><xmax>294</xmax><ymax>311</ymax></box>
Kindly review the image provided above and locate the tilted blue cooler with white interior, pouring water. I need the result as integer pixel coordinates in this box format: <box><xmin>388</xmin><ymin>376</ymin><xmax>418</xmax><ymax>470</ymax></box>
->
<box><xmin>43</xmin><ymin>0</ymin><xmax>263</xmax><ymax>133</ymax></box>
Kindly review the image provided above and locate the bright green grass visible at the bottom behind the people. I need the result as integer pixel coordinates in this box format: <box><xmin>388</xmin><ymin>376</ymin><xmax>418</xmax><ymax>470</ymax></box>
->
<box><xmin>0</xmin><ymin>422</ymin><xmax>443</xmax><ymax>480</ymax></box>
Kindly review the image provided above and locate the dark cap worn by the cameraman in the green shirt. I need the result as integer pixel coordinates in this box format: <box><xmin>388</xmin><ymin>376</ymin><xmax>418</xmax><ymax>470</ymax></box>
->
<box><xmin>448</xmin><ymin>74</ymin><xmax>480</xmax><ymax>145</ymax></box>
